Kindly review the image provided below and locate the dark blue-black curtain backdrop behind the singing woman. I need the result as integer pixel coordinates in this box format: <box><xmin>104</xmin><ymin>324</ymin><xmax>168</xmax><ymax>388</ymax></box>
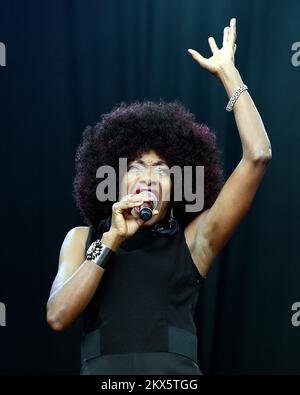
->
<box><xmin>0</xmin><ymin>0</ymin><xmax>300</xmax><ymax>374</ymax></box>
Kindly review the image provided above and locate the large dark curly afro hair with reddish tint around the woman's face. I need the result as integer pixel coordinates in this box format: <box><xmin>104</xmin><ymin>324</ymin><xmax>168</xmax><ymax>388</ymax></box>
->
<box><xmin>73</xmin><ymin>98</ymin><xmax>224</xmax><ymax>227</ymax></box>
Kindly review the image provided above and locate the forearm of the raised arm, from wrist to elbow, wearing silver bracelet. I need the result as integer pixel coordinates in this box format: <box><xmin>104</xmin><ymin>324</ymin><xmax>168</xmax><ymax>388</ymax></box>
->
<box><xmin>219</xmin><ymin>65</ymin><xmax>272</xmax><ymax>160</ymax></box>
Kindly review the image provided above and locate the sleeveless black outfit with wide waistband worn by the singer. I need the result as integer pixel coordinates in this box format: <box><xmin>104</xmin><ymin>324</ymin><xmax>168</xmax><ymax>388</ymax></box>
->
<box><xmin>80</xmin><ymin>219</ymin><xmax>204</xmax><ymax>375</ymax></box>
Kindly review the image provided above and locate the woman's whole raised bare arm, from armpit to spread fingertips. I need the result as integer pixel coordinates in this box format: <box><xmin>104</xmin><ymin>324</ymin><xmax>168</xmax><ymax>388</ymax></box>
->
<box><xmin>187</xmin><ymin>18</ymin><xmax>272</xmax><ymax>275</ymax></box>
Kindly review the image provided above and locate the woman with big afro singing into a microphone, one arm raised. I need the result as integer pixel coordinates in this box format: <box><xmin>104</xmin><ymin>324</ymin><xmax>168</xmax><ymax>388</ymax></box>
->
<box><xmin>47</xmin><ymin>18</ymin><xmax>272</xmax><ymax>375</ymax></box>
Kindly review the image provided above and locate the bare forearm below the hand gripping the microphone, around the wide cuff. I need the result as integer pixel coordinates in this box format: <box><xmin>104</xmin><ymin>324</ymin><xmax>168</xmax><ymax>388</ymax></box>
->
<box><xmin>47</xmin><ymin>232</ymin><xmax>121</xmax><ymax>331</ymax></box>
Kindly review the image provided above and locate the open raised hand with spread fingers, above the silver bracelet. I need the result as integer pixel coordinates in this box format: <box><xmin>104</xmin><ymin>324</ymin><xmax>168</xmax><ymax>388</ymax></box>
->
<box><xmin>188</xmin><ymin>18</ymin><xmax>237</xmax><ymax>76</ymax></box>
